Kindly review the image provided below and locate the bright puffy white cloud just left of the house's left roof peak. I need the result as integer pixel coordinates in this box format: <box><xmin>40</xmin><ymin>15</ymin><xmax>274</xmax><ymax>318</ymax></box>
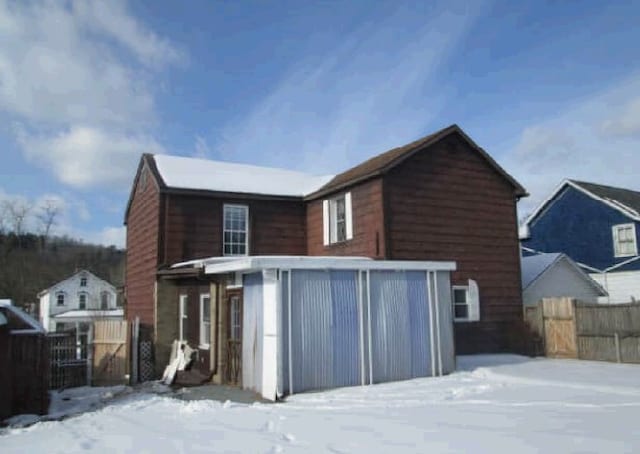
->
<box><xmin>18</xmin><ymin>126</ymin><xmax>164</xmax><ymax>190</ymax></box>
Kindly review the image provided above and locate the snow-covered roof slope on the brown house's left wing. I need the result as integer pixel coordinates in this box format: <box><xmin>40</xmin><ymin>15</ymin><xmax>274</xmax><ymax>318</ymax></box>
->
<box><xmin>153</xmin><ymin>155</ymin><xmax>333</xmax><ymax>197</ymax></box>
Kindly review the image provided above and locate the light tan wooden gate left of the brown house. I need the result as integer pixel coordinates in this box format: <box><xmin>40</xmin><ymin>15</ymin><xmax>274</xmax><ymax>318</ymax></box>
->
<box><xmin>93</xmin><ymin>320</ymin><xmax>129</xmax><ymax>386</ymax></box>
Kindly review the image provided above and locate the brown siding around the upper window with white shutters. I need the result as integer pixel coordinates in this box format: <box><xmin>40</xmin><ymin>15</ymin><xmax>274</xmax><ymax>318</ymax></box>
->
<box><xmin>307</xmin><ymin>178</ymin><xmax>385</xmax><ymax>258</ymax></box>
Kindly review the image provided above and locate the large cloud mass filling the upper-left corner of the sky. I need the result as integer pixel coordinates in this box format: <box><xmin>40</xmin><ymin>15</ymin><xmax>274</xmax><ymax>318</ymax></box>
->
<box><xmin>0</xmin><ymin>0</ymin><xmax>184</xmax><ymax>187</ymax></box>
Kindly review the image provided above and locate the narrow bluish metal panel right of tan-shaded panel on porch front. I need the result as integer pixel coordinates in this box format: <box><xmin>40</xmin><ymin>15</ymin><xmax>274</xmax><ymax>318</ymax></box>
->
<box><xmin>330</xmin><ymin>271</ymin><xmax>360</xmax><ymax>386</ymax></box>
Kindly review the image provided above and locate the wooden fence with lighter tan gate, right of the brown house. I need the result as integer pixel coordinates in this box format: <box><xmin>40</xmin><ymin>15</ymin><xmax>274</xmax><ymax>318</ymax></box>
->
<box><xmin>524</xmin><ymin>298</ymin><xmax>640</xmax><ymax>363</ymax></box>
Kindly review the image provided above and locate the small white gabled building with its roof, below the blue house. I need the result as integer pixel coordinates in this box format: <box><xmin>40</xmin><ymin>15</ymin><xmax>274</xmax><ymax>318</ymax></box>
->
<box><xmin>522</xmin><ymin>253</ymin><xmax>607</xmax><ymax>305</ymax></box>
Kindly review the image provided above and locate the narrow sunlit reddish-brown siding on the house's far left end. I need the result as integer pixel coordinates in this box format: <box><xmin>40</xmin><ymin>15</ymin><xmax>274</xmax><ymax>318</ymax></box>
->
<box><xmin>126</xmin><ymin>168</ymin><xmax>160</xmax><ymax>326</ymax></box>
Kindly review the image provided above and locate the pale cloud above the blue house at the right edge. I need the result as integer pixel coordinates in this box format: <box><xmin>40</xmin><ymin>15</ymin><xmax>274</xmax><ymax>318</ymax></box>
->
<box><xmin>502</xmin><ymin>74</ymin><xmax>640</xmax><ymax>215</ymax></box>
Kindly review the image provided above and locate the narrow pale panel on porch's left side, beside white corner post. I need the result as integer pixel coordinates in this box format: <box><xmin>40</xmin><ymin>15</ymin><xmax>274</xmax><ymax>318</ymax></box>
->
<box><xmin>242</xmin><ymin>273</ymin><xmax>263</xmax><ymax>392</ymax></box>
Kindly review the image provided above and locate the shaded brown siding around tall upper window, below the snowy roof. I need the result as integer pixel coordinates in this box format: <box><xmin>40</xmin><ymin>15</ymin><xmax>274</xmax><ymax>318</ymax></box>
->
<box><xmin>162</xmin><ymin>194</ymin><xmax>306</xmax><ymax>265</ymax></box>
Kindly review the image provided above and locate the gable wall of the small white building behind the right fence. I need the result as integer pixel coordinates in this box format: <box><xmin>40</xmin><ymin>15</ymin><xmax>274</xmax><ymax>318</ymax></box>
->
<box><xmin>522</xmin><ymin>259</ymin><xmax>598</xmax><ymax>304</ymax></box>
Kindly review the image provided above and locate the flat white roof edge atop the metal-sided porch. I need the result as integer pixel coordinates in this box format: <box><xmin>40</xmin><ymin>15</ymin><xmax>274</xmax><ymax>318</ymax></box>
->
<box><xmin>172</xmin><ymin>255</ymin><xmax>456</xmax><ymax>274</ymax></box>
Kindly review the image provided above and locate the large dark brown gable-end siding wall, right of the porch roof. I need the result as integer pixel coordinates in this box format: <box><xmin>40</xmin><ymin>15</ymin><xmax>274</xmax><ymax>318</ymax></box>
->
<box><xmin>385</xmin><ymin>136</ymin><xmax>522</xmax><ymax>353</ymax></box>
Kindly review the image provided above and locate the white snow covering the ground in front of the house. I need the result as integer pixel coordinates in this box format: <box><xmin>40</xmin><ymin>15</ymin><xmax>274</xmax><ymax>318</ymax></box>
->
<box><xmin>0</xmin><ymin>355</ymin><xmax>640</xmax><ymax>453</ymax></box>
